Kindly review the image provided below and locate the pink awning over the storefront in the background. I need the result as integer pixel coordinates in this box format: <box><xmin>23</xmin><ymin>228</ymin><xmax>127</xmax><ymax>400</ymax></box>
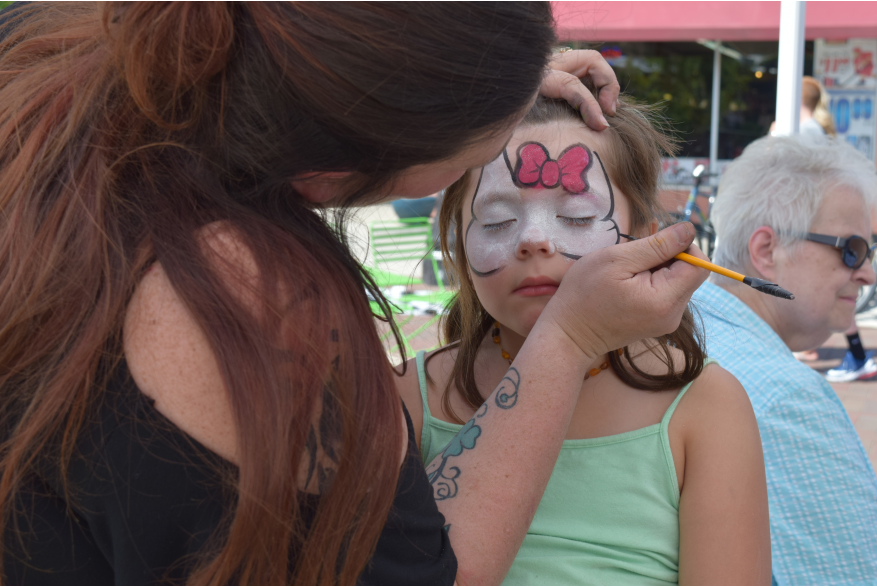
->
<box><xmin>552</xmin><ymin>0</ymin><xmax>877</xmax><ymax>42</ymax></box>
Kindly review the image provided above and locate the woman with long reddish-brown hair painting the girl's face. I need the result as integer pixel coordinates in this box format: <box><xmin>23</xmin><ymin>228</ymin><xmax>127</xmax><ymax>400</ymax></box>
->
<box><xmin>0</xmin><ymin>2</ymin><xmax>704</xmax><ymax>584</ymax></box>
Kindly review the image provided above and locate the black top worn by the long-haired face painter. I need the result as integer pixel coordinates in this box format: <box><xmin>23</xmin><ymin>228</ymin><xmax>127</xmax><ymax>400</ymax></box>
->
<box><xmin>3</xmin><ymin>363</ymin><xmax>457</xmax><ymax>585</ymax></box>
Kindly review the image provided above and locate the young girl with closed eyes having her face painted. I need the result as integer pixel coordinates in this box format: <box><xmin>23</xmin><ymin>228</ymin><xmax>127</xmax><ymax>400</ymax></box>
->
<box><xmin>400</xmin><ymin>100</ymin><xmax>770</xmax><ymax>585</ymax></box>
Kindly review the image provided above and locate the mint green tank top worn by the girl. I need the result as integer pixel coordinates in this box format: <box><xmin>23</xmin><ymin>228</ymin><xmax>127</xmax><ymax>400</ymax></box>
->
<box><xmin>417</xmin><ymin>351</ymin><xmax>715</xmax><ymax>585</ymax></box>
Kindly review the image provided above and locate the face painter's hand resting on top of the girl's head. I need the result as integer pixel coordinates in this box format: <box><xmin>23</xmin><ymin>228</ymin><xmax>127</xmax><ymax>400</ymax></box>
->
<box><xmin>539</xmin><ymin>50</ymin><xmax>621</xmax><ymax>131</ymax></box>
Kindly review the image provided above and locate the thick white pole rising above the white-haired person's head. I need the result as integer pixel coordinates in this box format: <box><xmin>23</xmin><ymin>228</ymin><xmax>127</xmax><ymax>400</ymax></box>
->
<box><xmin>774</xmin><ymin>1</ymin><xmax>807</xmax><ymax>135</ymax></box>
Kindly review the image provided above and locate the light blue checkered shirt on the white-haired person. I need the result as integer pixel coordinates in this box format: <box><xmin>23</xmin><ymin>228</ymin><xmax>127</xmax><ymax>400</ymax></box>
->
<box><xmin>693</xmin><ymin>283</ymin><xmax>877</xmax><ymax>585</ymax></box>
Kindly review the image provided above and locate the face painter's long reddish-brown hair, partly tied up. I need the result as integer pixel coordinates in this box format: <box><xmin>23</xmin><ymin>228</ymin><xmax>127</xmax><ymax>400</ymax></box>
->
<box><xmin>0</xmin><ymin>2</ymin><xmax>554</xmax><ymax>584</ymax></box>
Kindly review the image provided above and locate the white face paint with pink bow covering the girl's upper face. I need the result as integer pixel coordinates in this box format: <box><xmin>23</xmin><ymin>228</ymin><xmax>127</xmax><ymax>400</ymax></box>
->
<box><xmin>465</xmin><ymin>142</ymin><xmax>619</xmax><ymax>277</ymax></box>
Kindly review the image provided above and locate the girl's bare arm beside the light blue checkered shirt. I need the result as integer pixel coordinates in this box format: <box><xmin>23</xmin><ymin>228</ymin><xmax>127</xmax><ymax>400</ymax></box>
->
<box><xmin>674</xmin><ymin>364</ymin><xmax>770</xmax><ymax>585</ymax></box>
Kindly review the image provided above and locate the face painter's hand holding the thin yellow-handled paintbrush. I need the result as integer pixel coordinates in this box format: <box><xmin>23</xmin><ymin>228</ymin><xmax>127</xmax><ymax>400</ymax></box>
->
<box><xmin>537</xmin><ymin>222</ymin><xmax>709</xmax><ymax>358</ymax></box>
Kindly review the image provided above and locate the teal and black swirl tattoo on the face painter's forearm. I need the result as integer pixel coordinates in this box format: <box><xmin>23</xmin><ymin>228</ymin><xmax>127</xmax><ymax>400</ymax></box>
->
<box><xmin>426</xmin><ymin>367</ymin><xmax>521</xmax><ymax>500</ymax></box>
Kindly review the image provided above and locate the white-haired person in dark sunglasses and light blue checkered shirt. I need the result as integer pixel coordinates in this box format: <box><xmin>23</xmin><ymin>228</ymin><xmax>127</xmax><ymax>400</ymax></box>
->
<box><xmin>695</xmin><ymin>137</ymin><xmax>877</xmax><ymax>585</ymax></box>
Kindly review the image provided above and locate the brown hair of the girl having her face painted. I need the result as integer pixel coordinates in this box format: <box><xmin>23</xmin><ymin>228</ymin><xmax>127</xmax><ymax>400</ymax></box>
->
<box><xmin>432</xmin><ymin>96</ymin><xmax>705</xmax><ymax>424</ymax></box>
